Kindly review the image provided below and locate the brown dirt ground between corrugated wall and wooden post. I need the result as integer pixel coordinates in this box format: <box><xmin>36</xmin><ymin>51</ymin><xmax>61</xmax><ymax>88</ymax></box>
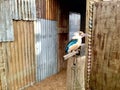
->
<box><xmin>26</xmin><ymin>70</ymin><xmax>67</xmax><ymax>90</ymax></box>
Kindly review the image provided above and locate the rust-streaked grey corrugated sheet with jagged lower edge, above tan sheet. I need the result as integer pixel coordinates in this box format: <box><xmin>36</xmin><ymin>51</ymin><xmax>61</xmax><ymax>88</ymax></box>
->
<box><xmin>11</xmin><ymin>0</ymin><xmax>36</xmax><ymax>20</ymax></box>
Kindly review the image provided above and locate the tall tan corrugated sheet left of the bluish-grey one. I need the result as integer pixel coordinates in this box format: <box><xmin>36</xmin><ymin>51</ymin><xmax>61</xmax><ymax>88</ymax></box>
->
<box><xmin>7</xmin><ymin>21</ymin><xmax>35</xmax><ymax>90</ymax></box>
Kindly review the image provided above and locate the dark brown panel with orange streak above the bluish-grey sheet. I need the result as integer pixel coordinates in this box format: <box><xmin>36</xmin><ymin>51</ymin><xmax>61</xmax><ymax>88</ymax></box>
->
<box><xmin>36</xmin><ymin>0</ymin><xmax>59</xmax><ymax>20</ymax></box>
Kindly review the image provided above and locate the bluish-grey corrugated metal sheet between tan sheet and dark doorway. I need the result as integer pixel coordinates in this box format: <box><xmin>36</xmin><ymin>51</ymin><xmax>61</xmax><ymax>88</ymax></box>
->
<box><xmin>35</xmin><ymin>19</ymin><xmax>57</xmax><ymax>81</ymax></box>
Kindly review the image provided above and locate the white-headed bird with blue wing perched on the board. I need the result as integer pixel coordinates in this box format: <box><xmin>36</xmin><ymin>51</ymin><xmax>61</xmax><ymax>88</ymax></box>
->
<box><xmin>65</xmin><ymin>31</ymin><xmax>88</xmax><ymax>53</ymax></box>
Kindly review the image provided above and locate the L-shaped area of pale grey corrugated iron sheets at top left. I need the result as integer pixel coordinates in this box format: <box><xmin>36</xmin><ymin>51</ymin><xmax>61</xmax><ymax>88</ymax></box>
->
<box><xmin>0</xmin><ymin>0</ymin><xmax>36</xmax><ymax>42</ymax></box>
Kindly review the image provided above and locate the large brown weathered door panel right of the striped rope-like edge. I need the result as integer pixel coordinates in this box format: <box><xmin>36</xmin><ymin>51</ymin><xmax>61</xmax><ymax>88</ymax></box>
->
<box><xmin>90</xmin><ymin>1</ymin><xmax>120</xmax><ymax>90</ymax></box>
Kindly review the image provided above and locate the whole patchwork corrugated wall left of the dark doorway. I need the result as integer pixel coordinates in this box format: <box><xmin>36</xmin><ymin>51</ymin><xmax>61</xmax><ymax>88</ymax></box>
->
<box><xmin>0</xmin><ymin>0</ymin><xmax>59</xmax><ymax>90</ymax></box>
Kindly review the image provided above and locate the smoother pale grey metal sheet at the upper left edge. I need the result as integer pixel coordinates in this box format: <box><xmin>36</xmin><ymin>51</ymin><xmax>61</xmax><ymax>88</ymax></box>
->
<box><xmin>0</xmin><ymin>0</ymin><xmax>14</xmax><ymax>42</ymax></box>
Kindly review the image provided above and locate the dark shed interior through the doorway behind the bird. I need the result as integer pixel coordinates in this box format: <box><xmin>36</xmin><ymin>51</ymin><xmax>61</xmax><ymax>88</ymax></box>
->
<box><xmin>56</xmin><ymin>0</ymin><xmax>86</xmax><ymax>70</ymax></box>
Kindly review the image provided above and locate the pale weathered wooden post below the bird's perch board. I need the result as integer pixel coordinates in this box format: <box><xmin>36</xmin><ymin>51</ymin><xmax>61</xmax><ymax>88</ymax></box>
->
<box><xmin>67</xmin><ymin>56</ymin><xmax>85</xmax><ymax>90</ymax></box>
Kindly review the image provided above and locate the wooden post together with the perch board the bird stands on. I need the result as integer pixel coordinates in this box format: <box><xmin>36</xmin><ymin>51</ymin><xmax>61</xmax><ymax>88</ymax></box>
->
<box><xmin>65</xmin><ymin>45</ymin><xmax>86</xmax><ymax>90</ymax></box>
